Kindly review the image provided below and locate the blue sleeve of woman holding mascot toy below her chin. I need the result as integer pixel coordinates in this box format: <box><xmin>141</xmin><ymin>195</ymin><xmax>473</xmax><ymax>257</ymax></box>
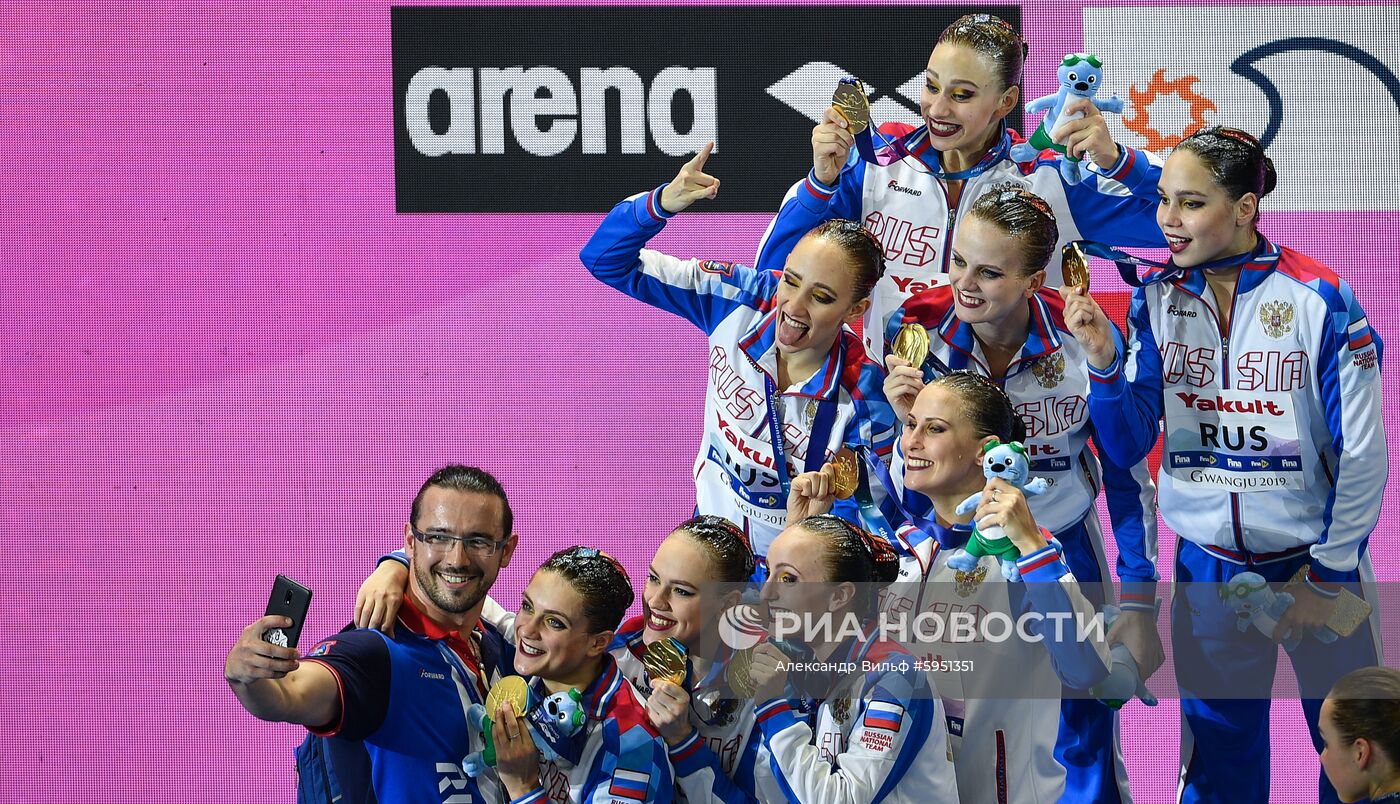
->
<box><xmin>1016</xmin><ymin>534</ymin><xmax>1113</xmax><ymax>689</ymax></box>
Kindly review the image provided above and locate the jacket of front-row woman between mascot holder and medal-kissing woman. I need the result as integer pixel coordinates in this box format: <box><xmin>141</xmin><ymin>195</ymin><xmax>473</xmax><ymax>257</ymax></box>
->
<box><xmin>608</xmin><ymin>615</ymin><xmax>753</xmax><ymax>804</ymax></box>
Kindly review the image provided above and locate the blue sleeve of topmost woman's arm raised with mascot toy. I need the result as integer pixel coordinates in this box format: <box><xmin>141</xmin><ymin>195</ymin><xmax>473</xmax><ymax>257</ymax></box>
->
<box><xmin>1058</xmin><ymin>146</ymin><xmax>1166</xmax><ymax>247</ymax></box>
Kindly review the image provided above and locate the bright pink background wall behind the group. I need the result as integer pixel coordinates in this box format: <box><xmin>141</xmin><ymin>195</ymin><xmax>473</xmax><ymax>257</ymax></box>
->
<box><xmin>0</xmin><ymin>0</ymin><xmax>1400</xmax><ymax>801</ymax></box>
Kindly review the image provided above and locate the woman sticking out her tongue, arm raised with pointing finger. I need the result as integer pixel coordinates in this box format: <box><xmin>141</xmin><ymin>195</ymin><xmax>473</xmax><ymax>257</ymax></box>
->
<box><xmin>580</xmin><ymin>144</ymin><xmax>895</xmax><ymax>574</ymax></box>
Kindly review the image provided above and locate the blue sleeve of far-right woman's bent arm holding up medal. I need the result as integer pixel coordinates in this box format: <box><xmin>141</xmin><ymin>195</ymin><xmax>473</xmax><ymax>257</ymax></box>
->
<box><xmin>1089</xmin><ymin>287</ymin><xmax>1162</xmax><ymax>466</ymax></box>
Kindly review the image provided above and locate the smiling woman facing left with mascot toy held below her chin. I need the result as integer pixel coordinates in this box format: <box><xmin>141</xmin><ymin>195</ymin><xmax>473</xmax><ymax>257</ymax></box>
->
<box><xmin>788</xmin><ymin>371</ymin><xmax>1110</xmax><ymax>803</ymax></box>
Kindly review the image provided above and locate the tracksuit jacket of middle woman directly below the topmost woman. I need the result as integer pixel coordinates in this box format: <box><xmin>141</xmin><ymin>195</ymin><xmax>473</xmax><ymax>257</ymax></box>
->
<box><xmin>885</xmin><ymin>286</ymin><xmax>1158</xmax><ymax>611</ymax></box>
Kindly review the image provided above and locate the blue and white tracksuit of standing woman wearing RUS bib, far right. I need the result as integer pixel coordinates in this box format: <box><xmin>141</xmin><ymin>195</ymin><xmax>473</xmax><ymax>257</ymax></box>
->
<box><xmin>1089</xmin><ymin>238</ymin><xmax>1389</xmax><ymax>803</ymax></box>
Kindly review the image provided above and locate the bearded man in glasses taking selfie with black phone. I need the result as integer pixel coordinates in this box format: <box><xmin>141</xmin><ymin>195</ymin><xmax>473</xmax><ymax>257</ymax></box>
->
<box><xmin>224</xmin><ymin>465</ymin><xmax>517</xmax><ymax>804</ymax></box>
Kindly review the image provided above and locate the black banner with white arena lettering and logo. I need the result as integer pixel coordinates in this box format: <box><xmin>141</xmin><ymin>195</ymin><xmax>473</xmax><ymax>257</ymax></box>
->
<box><xmin>391</xmin><ymin>6</ymin><xmax>1021</xmax><ymax>213</ymax></box>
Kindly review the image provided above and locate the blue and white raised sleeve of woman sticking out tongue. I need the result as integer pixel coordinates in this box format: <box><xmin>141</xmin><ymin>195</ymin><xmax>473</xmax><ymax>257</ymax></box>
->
<box><xmin>578</xmin><ymin>185</ymin><xmax>777</xmax><ymax>335</ymax></box>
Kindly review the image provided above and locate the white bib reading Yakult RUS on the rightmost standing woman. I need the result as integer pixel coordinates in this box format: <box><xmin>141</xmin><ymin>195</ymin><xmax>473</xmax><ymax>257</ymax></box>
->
<box><xmin>1162</xmin><ymin>388</ymin><xmax>1303</xmax><ymax>493</ymax></box>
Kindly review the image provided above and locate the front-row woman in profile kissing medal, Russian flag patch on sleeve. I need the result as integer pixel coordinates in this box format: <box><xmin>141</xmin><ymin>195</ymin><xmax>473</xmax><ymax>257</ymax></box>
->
<box><xmin>672</xmin><ymin>514</ymin><xmax>959</xmax><ymax>804</ymax></box>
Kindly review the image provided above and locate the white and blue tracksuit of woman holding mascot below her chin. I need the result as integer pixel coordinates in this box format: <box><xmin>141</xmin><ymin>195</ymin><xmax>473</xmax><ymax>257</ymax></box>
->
<box><xmin>881</xmin><ymin>522</ymin><xmax>1110</xmax><ymax>804</ymax></box>
